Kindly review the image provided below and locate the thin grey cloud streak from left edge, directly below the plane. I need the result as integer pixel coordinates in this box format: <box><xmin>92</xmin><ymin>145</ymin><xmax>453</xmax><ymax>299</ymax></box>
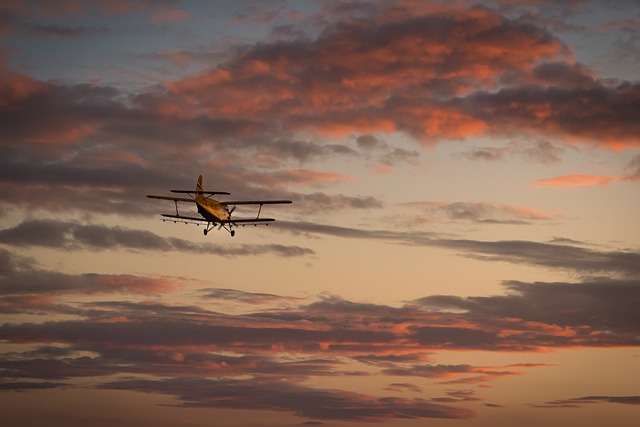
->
<box><xmin>0</xmin><ymin>220</ymin><xmax>314</xmax><ymax>257</ymax></box>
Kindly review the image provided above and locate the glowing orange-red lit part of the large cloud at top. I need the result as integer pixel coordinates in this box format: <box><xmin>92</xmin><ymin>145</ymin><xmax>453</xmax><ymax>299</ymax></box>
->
<box><xmin>160</xmin><ymin>9</ymin><xmax>566</xmax><ymax>144</ymax></box>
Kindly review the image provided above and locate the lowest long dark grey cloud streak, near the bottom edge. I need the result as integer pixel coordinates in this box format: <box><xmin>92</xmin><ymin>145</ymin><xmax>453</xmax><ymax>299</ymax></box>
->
<box><xmin>100</xmin><ymin>378</ymin><xmax>473</xmax><ymax>422</ymax></box>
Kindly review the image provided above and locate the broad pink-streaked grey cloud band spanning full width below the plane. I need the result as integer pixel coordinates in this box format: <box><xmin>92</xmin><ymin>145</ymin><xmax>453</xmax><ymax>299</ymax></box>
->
<box><xmin>0</xmin><ymin>272</ymin><xmax>640</xmax><ymax>362</ymax></box>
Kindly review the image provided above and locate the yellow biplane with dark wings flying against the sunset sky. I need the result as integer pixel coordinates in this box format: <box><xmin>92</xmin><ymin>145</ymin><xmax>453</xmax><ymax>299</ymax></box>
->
<box><xmin>147</xmin><ymin>175</ymin><xmax>293</xmax><ymax>237</ymax></box>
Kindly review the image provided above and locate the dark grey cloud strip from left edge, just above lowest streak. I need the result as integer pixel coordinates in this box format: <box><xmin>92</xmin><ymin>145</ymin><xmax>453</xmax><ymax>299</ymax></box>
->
<box><xmin>0</xmin><ymin>343</ymin><xmax>352</xmax><ymax>380</ymax></box>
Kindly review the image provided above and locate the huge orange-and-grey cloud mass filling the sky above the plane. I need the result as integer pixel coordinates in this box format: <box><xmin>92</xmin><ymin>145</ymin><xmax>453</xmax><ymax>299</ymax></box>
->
<box><xmin>0</xmin><ymin>3</ymin><xmax>640</xmax><ymax>224</ymax></box>
